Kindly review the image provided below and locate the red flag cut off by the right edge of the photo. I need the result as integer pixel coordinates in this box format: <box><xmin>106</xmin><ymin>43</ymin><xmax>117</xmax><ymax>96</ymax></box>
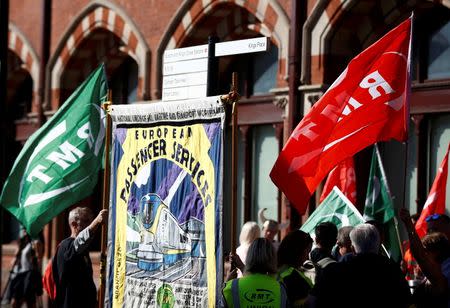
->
<box><xmin>416</xmin><ymin>144</ymin><xmax>450</xmax><ymax>238</ymax></box>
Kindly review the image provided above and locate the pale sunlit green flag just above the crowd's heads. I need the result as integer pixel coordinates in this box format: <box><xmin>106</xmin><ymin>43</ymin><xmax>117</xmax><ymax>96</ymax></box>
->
<box><xmin>300</xmin><ymin>186</ymin><xmax>364</xmax><ymax>234</ymax></box>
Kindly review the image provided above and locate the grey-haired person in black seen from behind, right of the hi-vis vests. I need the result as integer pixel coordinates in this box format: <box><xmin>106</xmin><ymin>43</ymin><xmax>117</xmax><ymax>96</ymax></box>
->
<box><xmin>309</xmin><ymin>224</ymin><xmax>412</xmax><ymax>307</ymax></box>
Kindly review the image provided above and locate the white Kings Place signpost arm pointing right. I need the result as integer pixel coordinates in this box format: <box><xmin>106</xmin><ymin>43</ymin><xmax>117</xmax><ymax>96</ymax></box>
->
<box><xmin>215</xmin><ymin>37</ymin><xmax>269</xmax><ymax>57</ymax></box>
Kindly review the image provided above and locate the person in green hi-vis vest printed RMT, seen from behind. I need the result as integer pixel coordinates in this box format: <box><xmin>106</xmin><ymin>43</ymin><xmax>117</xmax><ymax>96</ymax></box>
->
<box><xmin>222</xmin><ymin>238</ymin><xmax>288</xmax><ymax>308</ymax></box>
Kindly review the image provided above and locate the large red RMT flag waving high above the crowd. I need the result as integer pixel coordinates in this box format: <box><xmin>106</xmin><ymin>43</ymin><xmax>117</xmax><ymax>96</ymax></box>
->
<box><xmin>270</xmin><ymin>18</ymin><xmax>411</xmax><ymax>214</ymax></box>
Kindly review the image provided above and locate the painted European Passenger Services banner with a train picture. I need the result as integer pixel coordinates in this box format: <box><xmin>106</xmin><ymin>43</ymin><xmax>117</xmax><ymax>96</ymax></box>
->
<box><xmin>106</xmin><ymin>97</ymin><xmax>225</xmax><ymax>307</ymax></box>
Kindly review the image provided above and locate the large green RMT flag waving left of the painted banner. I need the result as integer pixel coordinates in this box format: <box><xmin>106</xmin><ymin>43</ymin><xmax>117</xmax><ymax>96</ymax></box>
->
<box><xmin>0</xmin><ymin>65</ymin><xmax>108</xmax><ymax>237</ymax></box>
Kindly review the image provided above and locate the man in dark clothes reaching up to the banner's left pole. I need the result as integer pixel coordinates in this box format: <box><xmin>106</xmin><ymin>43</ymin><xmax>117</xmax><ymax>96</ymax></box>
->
<box><xmin>52</xmin><ymin>207</ymin><xmax>108</xmax><ymax>308</ymax></box>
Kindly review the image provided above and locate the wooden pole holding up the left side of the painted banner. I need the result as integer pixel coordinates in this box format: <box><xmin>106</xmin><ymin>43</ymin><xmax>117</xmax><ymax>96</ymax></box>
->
<box><xmin>98</xmin><ymin>90</ymin><xmax>112</xmax><ymax>308</ymax></box>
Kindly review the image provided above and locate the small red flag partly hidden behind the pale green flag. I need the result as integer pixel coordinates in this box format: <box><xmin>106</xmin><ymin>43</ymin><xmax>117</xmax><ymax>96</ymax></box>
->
<box><xmin>319</xmin><ymin>157</ymin><xmax>356</xmax><ymax>204</ymax></box>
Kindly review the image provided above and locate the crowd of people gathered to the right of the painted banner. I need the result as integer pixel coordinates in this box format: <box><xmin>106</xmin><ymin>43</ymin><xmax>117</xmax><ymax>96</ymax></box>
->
<box><xmin>222</xmin><ymin>209</ymin><xmax>450</xmax><ymax>308</ymax></box>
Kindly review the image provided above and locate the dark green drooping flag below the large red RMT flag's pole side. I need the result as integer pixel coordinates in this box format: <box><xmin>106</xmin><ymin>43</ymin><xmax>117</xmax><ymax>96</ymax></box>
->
<box><xmin>364</xmin><ymin>144</ymin><xmax>402</xmax><ymax>262</ymax></box>
